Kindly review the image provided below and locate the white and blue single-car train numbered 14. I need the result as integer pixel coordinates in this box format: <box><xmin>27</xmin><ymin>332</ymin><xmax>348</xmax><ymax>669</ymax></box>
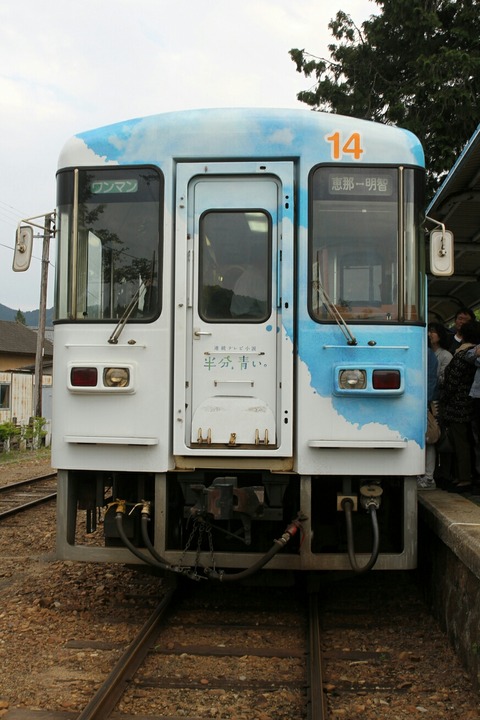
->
<box><xmin>15</xmin><ymin>109</ymin><xmax>450</xmax><ymax>579</ymax></box>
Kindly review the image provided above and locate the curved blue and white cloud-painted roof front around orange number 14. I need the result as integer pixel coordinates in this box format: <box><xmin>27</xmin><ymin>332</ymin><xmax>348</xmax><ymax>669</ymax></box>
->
<box><xmin>59</xmin><ymin>108</ymin><xmax>424</xmax><ymax>168</ymax></box>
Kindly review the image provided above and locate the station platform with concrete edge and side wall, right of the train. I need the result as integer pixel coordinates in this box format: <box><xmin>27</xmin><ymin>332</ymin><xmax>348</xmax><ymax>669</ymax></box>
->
<box><xmin>418</xmin><ymin>490</ymin><xmax>480</xmax><ymax>690</ymax></box>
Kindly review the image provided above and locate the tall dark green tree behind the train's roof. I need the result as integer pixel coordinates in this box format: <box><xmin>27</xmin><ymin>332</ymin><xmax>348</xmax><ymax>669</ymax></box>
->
<box><xmin>290</xmin><ymin>0</ymin><xmax>480</xmax><ymax>194</ymax></box>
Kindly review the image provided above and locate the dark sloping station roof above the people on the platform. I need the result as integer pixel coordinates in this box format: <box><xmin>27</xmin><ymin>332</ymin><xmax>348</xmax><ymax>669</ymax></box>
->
<box><xmin>427</xmin><ymin>125</ymin><xmax>480</xmax><ymax>324</ymax></box>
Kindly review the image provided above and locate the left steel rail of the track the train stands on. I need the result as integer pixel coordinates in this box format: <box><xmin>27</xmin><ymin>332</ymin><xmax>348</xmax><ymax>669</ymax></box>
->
<box><xmin>77</xmin><ymin>582</ymin><xmax>177</xmax><ymax>720</ymax></box>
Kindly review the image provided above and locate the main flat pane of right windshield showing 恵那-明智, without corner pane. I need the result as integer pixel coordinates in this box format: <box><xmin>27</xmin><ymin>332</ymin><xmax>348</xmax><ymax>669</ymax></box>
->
<box><xmin>310</xmin><ymin>166</ymin><xmax>399</xmax><ymax>321</ymax></box>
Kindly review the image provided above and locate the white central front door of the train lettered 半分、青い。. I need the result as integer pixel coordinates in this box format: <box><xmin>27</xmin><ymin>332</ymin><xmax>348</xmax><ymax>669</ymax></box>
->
<box><xmin>175</xmin><ymin>163</ymin><xmax>293</xmax><ymax>453</ymax></box>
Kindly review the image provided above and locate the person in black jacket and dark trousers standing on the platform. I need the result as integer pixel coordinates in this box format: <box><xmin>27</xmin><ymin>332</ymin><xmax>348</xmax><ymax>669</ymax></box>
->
<box><xmin>440</xmin><ymin>320</ymin><xmax>480</xmax><ymax>492</ymax></box>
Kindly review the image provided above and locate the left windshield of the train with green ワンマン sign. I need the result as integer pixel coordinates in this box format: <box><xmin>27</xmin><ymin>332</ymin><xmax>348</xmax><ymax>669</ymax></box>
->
<box><xmin>55</xmin><ymin>167</ymin><xmax>162</xmax><ymax>321</ymax></box>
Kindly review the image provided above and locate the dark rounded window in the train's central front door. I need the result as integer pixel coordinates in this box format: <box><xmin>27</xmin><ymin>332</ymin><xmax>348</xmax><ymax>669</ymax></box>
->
<box><xmin>198</xmin><ymin>210</ymin><xmax>272</xmax><ymax>323</ymax></box>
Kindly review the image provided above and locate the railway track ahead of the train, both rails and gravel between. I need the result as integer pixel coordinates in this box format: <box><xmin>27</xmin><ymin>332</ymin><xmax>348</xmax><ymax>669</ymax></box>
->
<box><xmin>72</xmin><ymin>586</ymin><xmax>326</xmax><ymax>720</ymax></box>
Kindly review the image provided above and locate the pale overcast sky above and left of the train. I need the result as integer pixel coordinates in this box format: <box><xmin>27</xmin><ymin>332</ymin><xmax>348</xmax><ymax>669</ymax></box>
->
<box><xmin>0</xmin><ymin>0</ymin><xmax>378</xmax><ymax>311</ymax></box>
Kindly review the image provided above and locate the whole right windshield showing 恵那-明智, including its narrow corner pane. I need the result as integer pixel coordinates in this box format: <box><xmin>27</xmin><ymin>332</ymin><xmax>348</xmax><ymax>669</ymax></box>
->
<box><xmin>310</xmin><ymin>166</ymin><xmax>423</xmax><ymax>322</ymax></box>
